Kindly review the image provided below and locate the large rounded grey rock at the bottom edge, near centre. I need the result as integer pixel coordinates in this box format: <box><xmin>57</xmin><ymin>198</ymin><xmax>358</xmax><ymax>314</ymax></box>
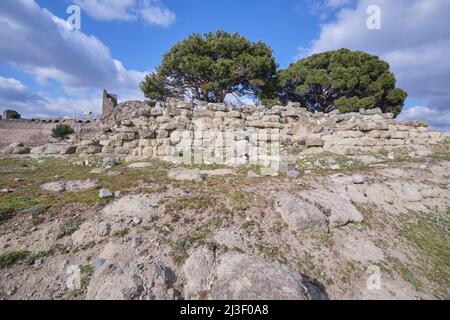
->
<box><xmin>183</xmin><ymin>249</ymin><xmax>311</xmax><ymax>300</ymax></box>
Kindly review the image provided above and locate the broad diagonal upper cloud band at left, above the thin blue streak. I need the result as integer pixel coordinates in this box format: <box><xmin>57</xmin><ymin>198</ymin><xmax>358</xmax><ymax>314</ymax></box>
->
<box><xmin>0</xmin><ymin>0</ymin><xmax>146</xmax><ymax>88</ymax></box>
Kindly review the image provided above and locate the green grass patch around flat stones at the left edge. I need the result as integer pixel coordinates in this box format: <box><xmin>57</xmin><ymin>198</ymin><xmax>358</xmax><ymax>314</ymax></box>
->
<box><xmin>0</xmin><ymin>158</ymin><xmax>173</xmax><ymax>224</ymax></box>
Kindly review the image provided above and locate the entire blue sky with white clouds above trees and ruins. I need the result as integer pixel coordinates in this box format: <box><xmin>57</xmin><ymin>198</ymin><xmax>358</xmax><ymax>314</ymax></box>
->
<box><xmin>0</xmin><ymin>0</ymin><xmax>450</xmax><ymax>130</ymax></box>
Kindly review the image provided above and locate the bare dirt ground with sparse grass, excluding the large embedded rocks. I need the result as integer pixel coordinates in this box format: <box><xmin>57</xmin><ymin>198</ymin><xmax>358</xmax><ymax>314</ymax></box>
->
<box><xmin>0</xmin><ymin>148</ymin><xmax>450</xmax><ymax>299</ymax></box>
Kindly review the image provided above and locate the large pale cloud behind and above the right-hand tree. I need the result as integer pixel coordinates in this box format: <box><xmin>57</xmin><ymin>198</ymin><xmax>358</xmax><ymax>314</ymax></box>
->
<box><xmin>303</xmin><ymin>0</ymin><xmax>450</xmax><ymax>130</ymax></box>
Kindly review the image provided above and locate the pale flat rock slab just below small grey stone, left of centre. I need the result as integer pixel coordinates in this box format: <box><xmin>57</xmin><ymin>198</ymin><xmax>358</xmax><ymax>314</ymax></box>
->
<box><xmin>101</xmin><ymin>194</ymin><xmax>159</xmax><ymax>219</ymax></box>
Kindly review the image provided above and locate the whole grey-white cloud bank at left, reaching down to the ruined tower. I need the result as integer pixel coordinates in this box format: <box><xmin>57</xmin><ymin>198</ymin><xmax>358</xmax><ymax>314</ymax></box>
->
<box><xmin>0</xmin><ymin>0</ymin><xmax>148</xmax><ymax>116</ymax></box>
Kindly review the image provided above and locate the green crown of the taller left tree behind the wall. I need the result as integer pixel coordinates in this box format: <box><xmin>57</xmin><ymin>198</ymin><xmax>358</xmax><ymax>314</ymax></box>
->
<box><xmin>141</xmin><ymin>31</ymin><xmax>277</xmax><ymax>102</ymax></box>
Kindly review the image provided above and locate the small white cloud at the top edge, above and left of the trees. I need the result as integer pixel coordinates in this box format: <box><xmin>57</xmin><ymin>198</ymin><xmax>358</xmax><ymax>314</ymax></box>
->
<box><xmin>76</xmin><ymin>0</ymin><xmax>176</xmax><ymax>27</ymax></box>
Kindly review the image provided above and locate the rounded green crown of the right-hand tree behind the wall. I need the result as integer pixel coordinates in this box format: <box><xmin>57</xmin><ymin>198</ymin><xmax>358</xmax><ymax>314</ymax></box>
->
<box><xmin>279</xmin><ymin>49</ymin><xmax>407</xmax><ymax>115</ymax></box>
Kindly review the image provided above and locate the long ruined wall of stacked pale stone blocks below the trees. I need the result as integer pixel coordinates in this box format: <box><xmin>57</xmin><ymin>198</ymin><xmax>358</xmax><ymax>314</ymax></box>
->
<box><xmin>78</xmin><ymin>98</ymin><xmax>449</xmax><ymax>165</ymax></box>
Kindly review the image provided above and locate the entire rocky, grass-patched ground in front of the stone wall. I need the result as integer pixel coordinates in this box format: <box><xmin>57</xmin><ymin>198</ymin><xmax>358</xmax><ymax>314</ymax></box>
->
<box><xmin>0</xmin><ymin>145</ymin><xmax>450</xmax><ymax>299</ymax></box>
